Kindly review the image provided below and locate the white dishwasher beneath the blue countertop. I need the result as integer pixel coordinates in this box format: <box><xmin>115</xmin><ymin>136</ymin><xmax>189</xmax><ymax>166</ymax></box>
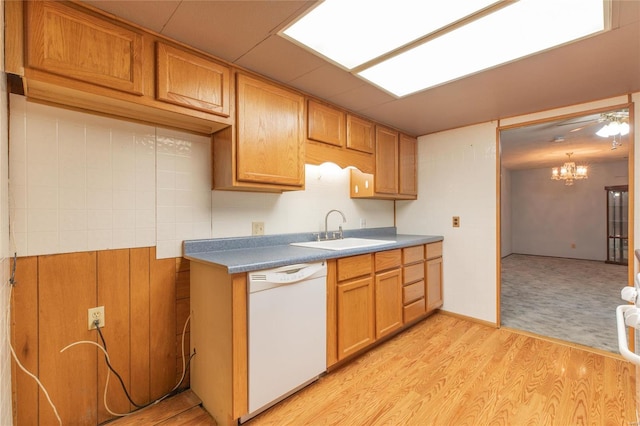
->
<box><xmin>240</xmin><ymin>262</ymin><xmax>327</xmax><ymax>422</ymax></box>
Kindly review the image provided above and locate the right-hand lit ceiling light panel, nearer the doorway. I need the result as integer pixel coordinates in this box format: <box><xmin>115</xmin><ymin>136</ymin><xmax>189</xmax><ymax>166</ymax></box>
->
<box><xmin>358</xmin><ymin>0</ymin><xmax>605</xmax><ymax>97</ymax></box>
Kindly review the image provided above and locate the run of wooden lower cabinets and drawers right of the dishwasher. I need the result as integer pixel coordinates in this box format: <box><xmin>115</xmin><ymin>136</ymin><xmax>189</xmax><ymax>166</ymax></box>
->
<box><xmin>327</xmin><ymin>242</ymin><xmax>442</xmax><ymax>367</ymax></box>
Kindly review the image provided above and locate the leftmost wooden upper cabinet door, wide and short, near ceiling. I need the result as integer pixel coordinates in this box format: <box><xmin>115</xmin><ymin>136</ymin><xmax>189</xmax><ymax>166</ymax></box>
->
<box><xmin>25</xmin><ymin>1</ymin><xmax>143</xmax><ymax>95</ymax></box>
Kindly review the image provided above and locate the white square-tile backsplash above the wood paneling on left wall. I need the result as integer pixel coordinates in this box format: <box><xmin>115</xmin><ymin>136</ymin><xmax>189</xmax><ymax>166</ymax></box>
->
<box><xmin>10</xmin><ymin>95</ymin><xmax>211</xmax><ymax>257</ymax></box>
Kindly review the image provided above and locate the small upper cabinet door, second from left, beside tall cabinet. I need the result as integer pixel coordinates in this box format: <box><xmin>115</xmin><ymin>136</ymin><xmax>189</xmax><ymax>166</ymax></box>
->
<box><xmin>156</xmin><ymin>42</ymin><xmax>231</xmax><ymax>117</ymax></box>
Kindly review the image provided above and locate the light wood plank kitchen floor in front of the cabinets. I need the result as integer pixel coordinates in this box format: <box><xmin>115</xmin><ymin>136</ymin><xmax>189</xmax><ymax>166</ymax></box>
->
<box><xmin>110</xmin><ymin>314</ymin><xmax>637</xmax><ymax>426</ymax></box>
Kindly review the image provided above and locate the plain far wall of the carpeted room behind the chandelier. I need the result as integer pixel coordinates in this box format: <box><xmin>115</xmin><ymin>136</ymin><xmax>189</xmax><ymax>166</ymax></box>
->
<box><xmin>511</xmin><ymin>159</ymin><xmax>628</xmax><ymax>261</ymax></box>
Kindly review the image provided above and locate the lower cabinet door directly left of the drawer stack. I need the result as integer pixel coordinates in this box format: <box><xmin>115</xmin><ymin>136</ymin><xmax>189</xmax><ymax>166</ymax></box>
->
<box><xmin>375</xmin><ymin>269</ymin><xmax>403</xmax><ymax>339</ymax></box>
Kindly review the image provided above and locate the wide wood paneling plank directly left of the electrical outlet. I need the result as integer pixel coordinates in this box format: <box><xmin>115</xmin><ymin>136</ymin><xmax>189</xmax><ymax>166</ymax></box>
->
<box><xmin>38</xmin><ymin>252</ymin><xmax>98</xmax><ymax>425</ymax></box>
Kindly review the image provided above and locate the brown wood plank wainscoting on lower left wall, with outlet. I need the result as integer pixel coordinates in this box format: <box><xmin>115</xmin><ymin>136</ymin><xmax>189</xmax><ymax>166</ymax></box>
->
<box><xmin>11</xmin><ymin>247</ymin><xmax>189</xmax><ymax>425</ymax></box>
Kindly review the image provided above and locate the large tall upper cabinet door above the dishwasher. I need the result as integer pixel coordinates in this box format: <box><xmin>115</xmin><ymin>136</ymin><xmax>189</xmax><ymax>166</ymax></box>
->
<box><xmin>236</xmin><ymin>74</ymin><xmax>304</xmax><ymax>187</ymax></box>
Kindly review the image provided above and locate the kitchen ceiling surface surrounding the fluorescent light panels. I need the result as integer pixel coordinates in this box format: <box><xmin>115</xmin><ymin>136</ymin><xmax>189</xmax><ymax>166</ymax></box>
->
<box><xmin>84</xmin><ymin>0</ymin><xmax>640</xmax><ymax>169</ymax></box>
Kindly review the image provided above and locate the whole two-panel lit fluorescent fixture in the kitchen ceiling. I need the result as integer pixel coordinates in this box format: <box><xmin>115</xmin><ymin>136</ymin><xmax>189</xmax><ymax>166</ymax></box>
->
<box><xmin>284</xmin><ymin>0</ymin><xmax>605</xmax><ymax>97</ymax></box>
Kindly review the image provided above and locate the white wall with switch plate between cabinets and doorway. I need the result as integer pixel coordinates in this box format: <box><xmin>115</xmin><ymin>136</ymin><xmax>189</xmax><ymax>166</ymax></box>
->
<box><xmin>397</xmin><ymin>122</ymin><xmax>497</xmax><ymax>322</ymax></box>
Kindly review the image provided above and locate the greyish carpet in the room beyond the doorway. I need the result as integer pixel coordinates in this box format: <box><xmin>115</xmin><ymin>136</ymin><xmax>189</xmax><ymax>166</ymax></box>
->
<box><xmin>500</xmin><ymin>254</ymin><xmax>627</xmax><ymax>353</ymax></box>
